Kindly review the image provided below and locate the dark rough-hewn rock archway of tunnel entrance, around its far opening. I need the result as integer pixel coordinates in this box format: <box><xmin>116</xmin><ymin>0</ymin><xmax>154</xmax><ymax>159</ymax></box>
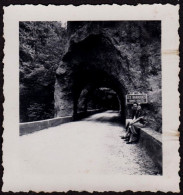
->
<box><xmin>55</xmin><ymin>33</ymin><xmax>132</xmax><ymax>123</ymax></box>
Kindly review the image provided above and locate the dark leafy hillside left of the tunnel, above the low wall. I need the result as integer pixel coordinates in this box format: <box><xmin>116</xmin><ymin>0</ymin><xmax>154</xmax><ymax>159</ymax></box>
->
<box><xmin>19</xmin><ymin>22</ymin><xmax>67</xmax><ymax>122</ymax></box>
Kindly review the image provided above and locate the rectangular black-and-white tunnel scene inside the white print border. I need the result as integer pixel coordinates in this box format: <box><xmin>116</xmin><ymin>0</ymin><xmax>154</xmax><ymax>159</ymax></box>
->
<box><xmin>19</xmin><ymin>21</ymin><xmax>162</xmax><ymax>175</ymax></box>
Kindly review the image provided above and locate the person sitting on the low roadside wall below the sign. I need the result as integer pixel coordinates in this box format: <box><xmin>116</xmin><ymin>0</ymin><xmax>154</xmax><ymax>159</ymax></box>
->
<box><xmin>122</xmin><ymin>103</ymin><xmax>144</xmax><ymax>144</ymax></box>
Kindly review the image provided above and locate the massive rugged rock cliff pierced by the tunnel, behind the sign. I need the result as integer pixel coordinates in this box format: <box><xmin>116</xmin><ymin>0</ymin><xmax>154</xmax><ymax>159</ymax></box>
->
<box><xmin>54</xmin><ymin>21</ymin><xmax>161</xmax><ymax>131</ymax></box>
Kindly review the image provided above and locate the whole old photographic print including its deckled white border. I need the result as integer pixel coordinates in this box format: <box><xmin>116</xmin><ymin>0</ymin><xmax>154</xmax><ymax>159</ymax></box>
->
<box><xmin>4</xmin><ymin>5</ymin><xmax>179</xmax><ymax>192</ymax></box>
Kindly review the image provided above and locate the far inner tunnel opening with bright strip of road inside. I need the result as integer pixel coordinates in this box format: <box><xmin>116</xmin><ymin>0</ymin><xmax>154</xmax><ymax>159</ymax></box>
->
<box><xmin>74</xmin><ymin>87</ymin><xmax>124</xmax><ymax>125</ymax></box>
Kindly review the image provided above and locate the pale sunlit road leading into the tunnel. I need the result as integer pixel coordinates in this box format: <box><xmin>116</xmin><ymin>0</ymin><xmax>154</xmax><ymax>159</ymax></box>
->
<box><xmin>20</xmin><ymin>111</ymin><xmax>158</xmax><ymax>175</ymax></box>
